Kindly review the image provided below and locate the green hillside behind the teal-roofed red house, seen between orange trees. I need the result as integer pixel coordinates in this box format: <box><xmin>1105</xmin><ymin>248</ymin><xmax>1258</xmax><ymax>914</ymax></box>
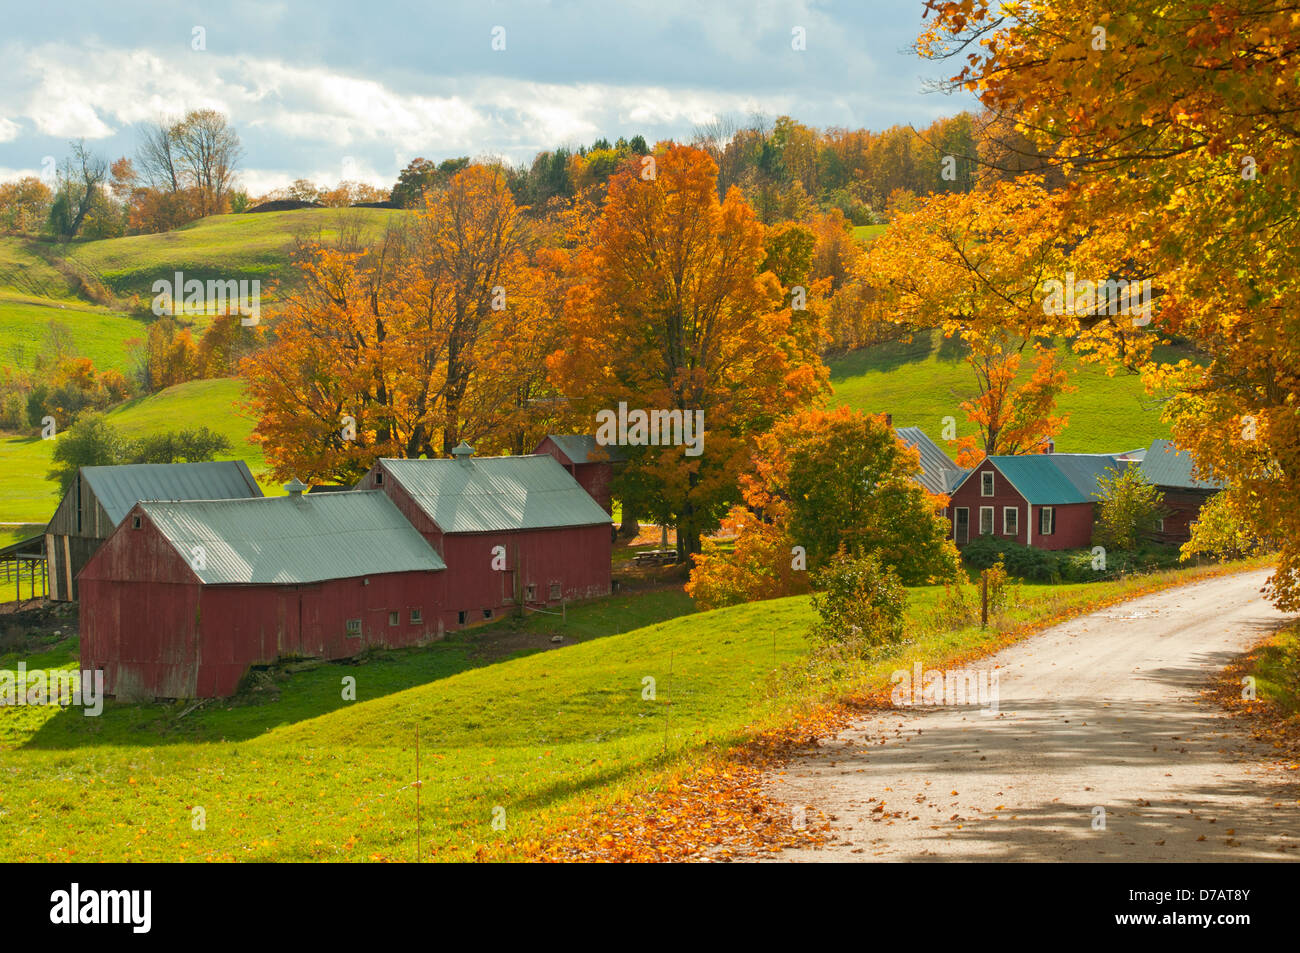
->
<box><xmin>828</xmin><ymin>330</ymin><xmax>1192</xmax><ymax>454</ymax></box>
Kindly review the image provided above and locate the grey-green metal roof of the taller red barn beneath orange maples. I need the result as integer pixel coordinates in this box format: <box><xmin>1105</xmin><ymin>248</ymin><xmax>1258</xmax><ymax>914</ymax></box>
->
<box><xmin>380</xmin><ymin>454</ymin><xmax>610</xmax><ymax>533</ymax></box>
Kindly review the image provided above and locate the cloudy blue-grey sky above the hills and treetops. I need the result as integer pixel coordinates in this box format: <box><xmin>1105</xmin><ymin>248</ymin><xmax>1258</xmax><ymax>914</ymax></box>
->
<box><xmin>0</xmin><ymin>0</ymin><xmax>971</xmax><ymax>194</ymax></box>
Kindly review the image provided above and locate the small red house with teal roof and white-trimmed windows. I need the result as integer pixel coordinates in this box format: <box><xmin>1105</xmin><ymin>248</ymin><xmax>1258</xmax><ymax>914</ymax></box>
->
<box><xmin>950</xmin><ymin>454</ymin><xmax>1130</xmax><ymax>550</ymax></box>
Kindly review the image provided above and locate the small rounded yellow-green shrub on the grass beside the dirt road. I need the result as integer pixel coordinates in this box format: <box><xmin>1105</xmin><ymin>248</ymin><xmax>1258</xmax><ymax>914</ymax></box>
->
<box><xmin>811</xmin><ymin>550</ymin><xmax>907</xmax><ymax>651</ymax></box>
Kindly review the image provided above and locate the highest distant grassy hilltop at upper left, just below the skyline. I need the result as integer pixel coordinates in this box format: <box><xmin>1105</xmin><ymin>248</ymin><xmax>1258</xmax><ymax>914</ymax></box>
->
<box><xmin>68</xmin><ymin>208</ymin><xmax>407</xmax><ymax>298</ymax></box>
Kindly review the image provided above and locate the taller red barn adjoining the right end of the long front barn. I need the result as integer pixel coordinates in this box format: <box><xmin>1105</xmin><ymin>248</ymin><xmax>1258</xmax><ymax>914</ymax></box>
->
<box><xmin>358</xmin><ymin>443</ymin><xmax>611</xmax><ymax>629</ymax></box>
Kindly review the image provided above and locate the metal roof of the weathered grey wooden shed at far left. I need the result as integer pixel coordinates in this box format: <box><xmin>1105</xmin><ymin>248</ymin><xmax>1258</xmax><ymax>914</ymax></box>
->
<box><xmin>81</xmin><ymin>460</ymin><xmax>263</xmax><ymax>525</ymax></box>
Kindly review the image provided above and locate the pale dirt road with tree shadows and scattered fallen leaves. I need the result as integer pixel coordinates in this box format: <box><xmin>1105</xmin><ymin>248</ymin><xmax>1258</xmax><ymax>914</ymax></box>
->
<box><xmin>771</xmin><ymin>572</ymin><xmax>1300</xmax><ymax>862</ymax></box>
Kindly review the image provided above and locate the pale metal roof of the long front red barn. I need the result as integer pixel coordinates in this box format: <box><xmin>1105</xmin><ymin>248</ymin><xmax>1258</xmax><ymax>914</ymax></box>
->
<box><xmin>135</xmin><ymin>490</ymin><xmax>447</xmax><ymax>585</ymax></box>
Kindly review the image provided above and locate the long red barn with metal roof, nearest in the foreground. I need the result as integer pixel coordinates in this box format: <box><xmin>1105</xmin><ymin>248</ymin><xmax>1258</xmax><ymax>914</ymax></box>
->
<box><xmin>78</xmin><ymin>482</ymin><xmax>446</xmax><ymax>701</ymax></box>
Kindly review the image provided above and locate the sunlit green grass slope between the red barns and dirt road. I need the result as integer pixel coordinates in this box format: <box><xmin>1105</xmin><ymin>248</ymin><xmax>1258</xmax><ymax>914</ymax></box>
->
<box><xmin>0</xmin><ymin>553</ymin><xmax>1258</xmax><ymax>861</ymax></box>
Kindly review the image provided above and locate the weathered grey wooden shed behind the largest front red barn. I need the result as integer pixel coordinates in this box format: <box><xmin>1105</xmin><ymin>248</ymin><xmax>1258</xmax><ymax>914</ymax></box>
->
<box><xmin>46</xmin><ymin>460</ymin><xmax>263</xmax><ymax>602</ymax></box>
